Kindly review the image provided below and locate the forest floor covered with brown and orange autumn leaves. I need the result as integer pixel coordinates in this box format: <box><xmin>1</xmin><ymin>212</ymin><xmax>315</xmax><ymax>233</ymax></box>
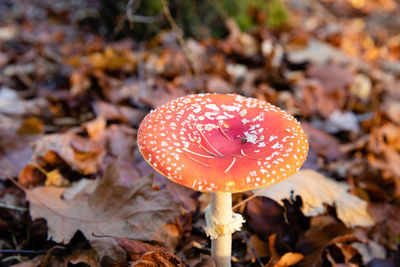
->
<box><xmin>0</xmin><ymin>0</ymin><xmax>400</xmax><ymax>267</ymax></box>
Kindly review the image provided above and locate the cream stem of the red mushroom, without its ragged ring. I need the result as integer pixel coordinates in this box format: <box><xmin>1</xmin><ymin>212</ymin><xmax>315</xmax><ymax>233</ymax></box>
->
<box><xmin>211</xmin><ymin>192</ymin><xmax>232</xmax><ymax>267</ymax></box>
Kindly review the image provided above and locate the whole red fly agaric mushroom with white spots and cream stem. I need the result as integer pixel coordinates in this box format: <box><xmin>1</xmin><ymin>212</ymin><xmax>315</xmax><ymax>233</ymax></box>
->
<box><xmin>137</xmin><ymin>94</ymin><xmax>308</xmax><ymax>267</ymax></box>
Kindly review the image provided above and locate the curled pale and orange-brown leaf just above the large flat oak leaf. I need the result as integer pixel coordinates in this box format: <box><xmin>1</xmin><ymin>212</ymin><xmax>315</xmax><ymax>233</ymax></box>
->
<box><xmin>32</xmin><ymin>132</ymin><xmax>104</xmax><ymax>174</ymax></box>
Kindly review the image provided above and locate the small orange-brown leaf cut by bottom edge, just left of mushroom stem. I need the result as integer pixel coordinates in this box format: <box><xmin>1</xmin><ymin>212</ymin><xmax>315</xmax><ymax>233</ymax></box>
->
<box><xmin>132</xmin><ymin>250</ymin><xmax>184</xmax><ymax>267</ymax></box>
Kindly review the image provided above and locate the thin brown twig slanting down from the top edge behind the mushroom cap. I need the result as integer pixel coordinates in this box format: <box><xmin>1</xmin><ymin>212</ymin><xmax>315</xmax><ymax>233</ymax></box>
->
<box><xmin>160</xmin><ymin>0</ymin><xmax>203</xmax><ymax>85</ymax></box>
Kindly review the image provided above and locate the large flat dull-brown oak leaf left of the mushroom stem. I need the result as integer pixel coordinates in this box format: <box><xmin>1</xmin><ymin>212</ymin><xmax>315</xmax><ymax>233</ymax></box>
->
<box><xmin>26</xmin><ymin>162</ymin><xmax>179</xmax><ymax>259</ymax></box>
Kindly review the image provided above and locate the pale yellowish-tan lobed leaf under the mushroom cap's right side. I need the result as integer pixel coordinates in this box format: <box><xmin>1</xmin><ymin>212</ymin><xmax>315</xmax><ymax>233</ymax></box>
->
<box><xmin>254</xmin><ymin>170</ymin><xmax>374</xmax><ymax>227</ymax></box>
